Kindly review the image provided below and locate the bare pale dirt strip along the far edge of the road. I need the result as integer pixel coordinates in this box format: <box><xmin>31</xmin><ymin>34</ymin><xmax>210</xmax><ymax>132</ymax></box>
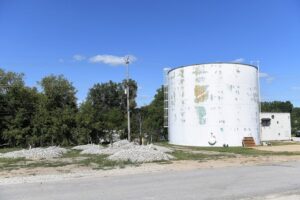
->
<box><xmin>0</xmin><ymin>152</ymin><xmax>300</xmax><ymax>183</ymax></box>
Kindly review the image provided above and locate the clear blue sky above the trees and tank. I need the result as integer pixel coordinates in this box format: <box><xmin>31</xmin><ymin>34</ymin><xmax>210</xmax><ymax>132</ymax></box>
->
<box><xmin>0</xmin><ymin>0</ymin><xmax>300</xmax><ymax>106</ymax></box>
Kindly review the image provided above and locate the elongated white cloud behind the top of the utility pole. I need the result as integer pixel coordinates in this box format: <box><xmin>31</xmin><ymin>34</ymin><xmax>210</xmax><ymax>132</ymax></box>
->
<box><xmin>89</xmin><ymin>54</ymin><xmax>137</xmax><ymax>65</ymax></box>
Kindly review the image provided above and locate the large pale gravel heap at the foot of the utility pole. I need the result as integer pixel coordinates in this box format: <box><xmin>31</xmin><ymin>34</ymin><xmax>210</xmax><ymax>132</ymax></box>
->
<box><xmin>76</xmin><ymin>140</ymin><xmax>173</xmax><ymax>162</ymax></box>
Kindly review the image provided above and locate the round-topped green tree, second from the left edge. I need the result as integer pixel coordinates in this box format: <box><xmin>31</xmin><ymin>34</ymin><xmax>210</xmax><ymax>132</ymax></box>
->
<box><xmin>34</xmin><ymin>75</ymin><xmax>77</xmax><ymax>145</ymax></box>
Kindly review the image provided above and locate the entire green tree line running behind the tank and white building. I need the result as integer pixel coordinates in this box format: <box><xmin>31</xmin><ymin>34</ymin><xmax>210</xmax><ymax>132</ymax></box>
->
<box><xmin>0</xmin><ymin>69</ymin><xmax>300</xmax><ymax>147</ymax></box>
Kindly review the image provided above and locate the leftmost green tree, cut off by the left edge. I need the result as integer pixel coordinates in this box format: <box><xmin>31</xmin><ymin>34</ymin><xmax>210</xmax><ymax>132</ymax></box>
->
<box><xmin>0</xmin><ymin>70</ymin><xmax>38</xmax><ymax>146</ymax></box>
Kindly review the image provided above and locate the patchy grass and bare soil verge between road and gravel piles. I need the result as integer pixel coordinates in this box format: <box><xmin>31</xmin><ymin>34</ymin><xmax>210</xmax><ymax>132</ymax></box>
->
<box><xmin>0</xmin><ymin>144</ymin><xmax>300</xmax><ymax>184</ymax></box>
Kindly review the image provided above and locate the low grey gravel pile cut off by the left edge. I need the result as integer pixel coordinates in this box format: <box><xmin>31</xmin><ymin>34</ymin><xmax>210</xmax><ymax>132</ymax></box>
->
<box><xmin>0</xmin><ymin>146</ymin><xmax>68</xmax><ymax>159</ymax></box>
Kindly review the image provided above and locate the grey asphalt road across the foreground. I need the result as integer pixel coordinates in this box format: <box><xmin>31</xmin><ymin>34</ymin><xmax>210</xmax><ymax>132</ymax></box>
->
<box><xmin>0</xmin><ymin>162</ymin><xmax>300</xmax><ymax>200</ymax></box>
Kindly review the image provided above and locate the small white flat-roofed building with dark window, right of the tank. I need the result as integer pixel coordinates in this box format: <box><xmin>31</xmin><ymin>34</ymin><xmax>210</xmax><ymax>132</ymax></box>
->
<box><xmin>260</xmin><ymin>113</ymin><xmax>292</xmax><ymax>141</ymax></box>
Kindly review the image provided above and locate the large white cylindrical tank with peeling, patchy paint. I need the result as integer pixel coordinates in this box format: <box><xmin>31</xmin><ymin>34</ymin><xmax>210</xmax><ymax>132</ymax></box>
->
<box><xmin>167</xmin><ymin>63</ymin><xmax>260</xmax><ymax>146</ymax></box>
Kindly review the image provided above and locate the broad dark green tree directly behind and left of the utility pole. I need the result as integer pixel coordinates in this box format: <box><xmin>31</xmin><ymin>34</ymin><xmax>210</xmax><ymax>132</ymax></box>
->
<box><xmin>78</xmin><ymin>80</ymin><xmax>137</xmax><ymax>143</ymax></box>
